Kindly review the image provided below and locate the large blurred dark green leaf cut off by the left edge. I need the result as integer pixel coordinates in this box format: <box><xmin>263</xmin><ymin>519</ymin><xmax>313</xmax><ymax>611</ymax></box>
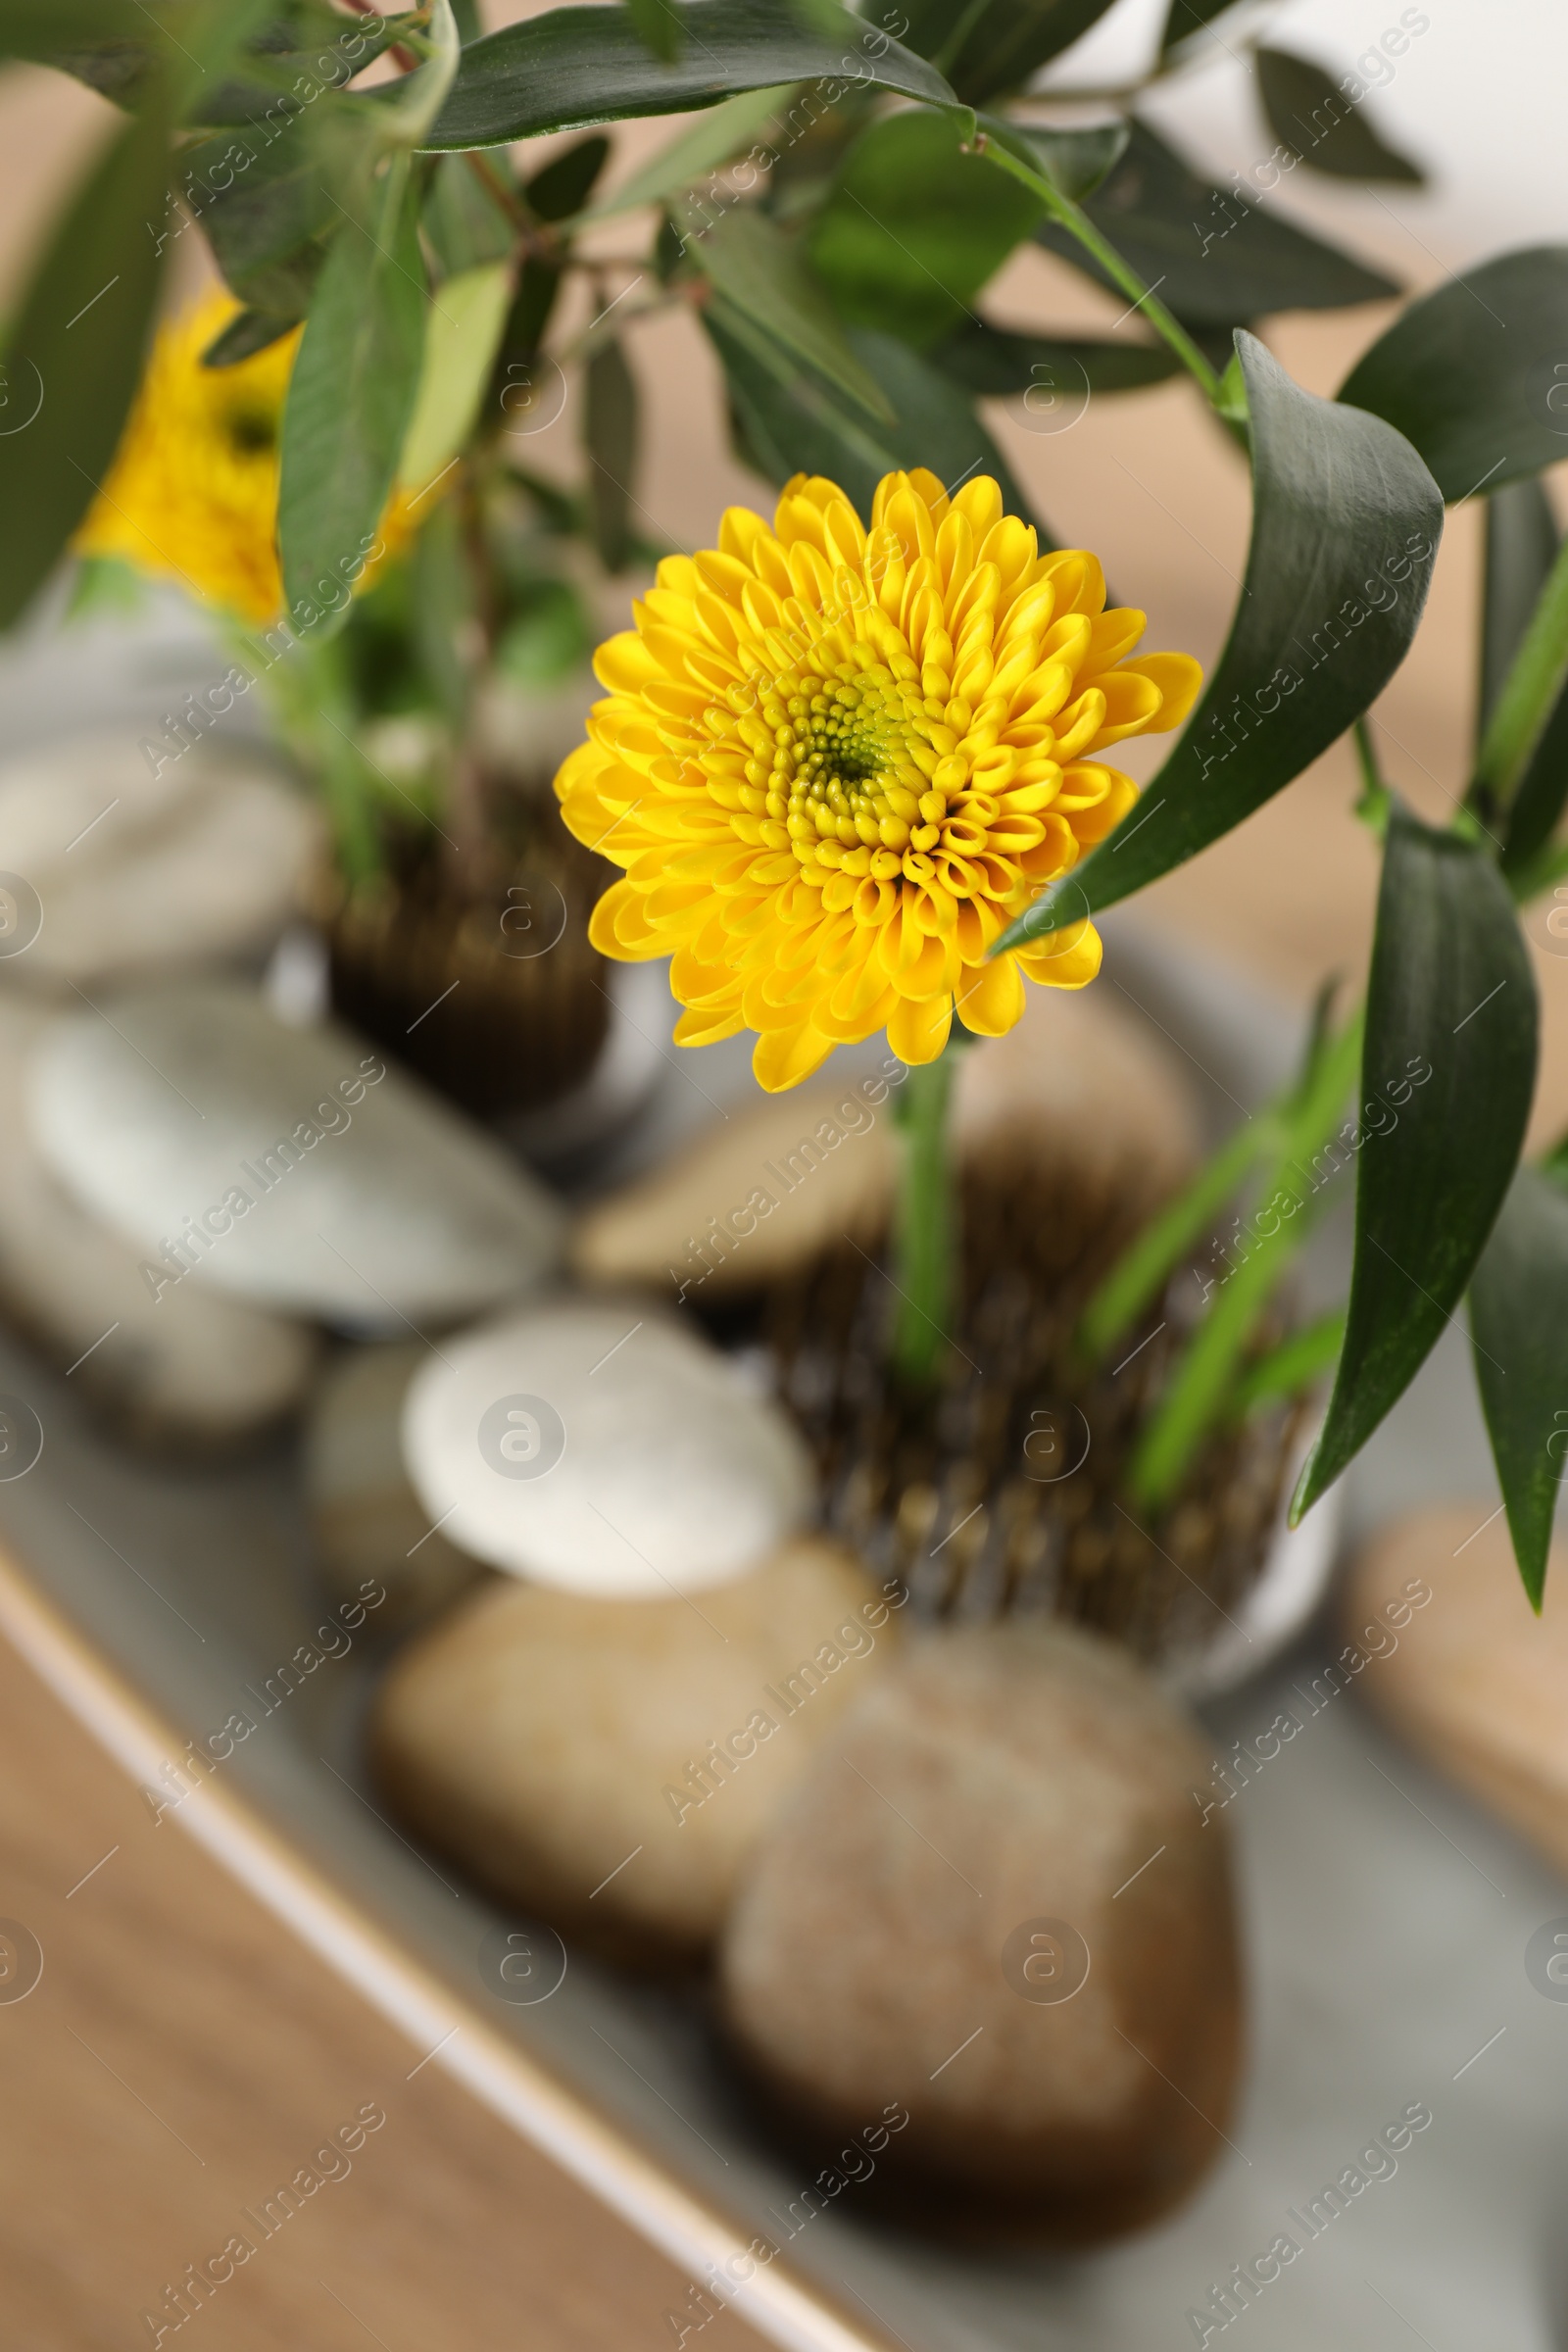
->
<box><xmin>0</xmin><ymin>75</ymin><xmax>172</xmax><ymax>628</ymax></box>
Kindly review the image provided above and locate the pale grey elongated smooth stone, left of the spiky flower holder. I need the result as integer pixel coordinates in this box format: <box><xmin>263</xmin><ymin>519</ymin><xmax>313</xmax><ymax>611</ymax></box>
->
<box><xmin>28</xmin><ymin>978</ymin><xmax>562</xmax><ymax>1331</ymax></box>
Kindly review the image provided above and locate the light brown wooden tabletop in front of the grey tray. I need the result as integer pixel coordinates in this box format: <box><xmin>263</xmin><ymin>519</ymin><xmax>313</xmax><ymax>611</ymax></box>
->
<box><xmin>0</xmin><ymin>1644</ymin><xmax>760</xmax><ymax>2352</ymax></box>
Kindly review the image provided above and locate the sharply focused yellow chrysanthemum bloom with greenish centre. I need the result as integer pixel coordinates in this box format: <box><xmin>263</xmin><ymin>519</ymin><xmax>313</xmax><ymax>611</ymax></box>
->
<box><xmin>555</xmin><ymin>468</ymin><xmax>1201</xmax><ymax>1092</ymax></box>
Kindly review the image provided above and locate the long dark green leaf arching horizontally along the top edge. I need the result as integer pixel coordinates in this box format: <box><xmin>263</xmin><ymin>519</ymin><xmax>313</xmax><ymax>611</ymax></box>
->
<box><xmin>425</xmin><ymin>0</ymin><xmax>956</xmax><ymax>148</ymax></box>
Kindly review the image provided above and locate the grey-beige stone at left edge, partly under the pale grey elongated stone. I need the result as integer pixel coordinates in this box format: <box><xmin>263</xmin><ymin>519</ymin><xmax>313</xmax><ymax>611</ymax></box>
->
<box><xmin>0</xmin><ymin>1000</ymin><xmax>315</xmax><ymax>1448</ymax></box>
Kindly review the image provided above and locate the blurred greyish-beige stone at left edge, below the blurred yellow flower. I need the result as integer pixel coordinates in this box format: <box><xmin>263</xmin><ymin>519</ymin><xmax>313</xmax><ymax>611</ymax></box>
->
<box><xmin>0</xmin><ymin>729</ymin><xmax>322</xmax><ymax>988</ymax></box>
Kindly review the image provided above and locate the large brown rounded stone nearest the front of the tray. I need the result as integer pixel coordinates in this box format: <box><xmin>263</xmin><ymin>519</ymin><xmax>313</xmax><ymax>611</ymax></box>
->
<box><xmin>721</xmin><ymin>1628</ymin><xmax>1242</xmax><ymax>2246</ymax></box>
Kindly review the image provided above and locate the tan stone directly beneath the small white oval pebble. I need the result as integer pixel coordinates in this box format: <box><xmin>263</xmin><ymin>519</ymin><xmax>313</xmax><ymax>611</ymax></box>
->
<box><xmin>371</xmin><ymin>1541</ymin><xmax>901</xmax><ymax>1966</ymax></box>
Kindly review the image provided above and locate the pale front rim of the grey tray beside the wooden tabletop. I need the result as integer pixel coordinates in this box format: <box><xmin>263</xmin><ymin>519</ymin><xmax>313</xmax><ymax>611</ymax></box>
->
<box><xmin>0</xmin><ymin>1543</ymin><xmax>886</xmax><ymax>2352</ymax></box>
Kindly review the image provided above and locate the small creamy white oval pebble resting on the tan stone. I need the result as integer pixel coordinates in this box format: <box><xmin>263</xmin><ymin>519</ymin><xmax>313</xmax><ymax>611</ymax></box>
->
<box><xmin>402</xmin><ymin>1300</ymin><xmax>813</xmax><ymax>1594</ymax></box>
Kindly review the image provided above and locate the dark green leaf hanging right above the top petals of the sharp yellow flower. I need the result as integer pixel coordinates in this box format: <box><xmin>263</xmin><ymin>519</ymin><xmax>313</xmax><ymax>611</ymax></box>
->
<box><xmin>703</xmin><ymin>301</ymin><xmax>1055</xmax><ymax>533</ymax></box>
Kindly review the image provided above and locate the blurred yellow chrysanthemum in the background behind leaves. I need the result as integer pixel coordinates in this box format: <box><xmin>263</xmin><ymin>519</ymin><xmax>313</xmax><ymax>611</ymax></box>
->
<box><xmin>75</xmin><ymin>287</ymin><xmax>409</xmax><ymax>625</ymax></box>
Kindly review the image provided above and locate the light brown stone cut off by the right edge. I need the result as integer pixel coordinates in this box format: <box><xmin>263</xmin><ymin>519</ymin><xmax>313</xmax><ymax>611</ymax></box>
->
<box><xmin>1343</xmin><ymin>1503</ymin><xmax>1568</xmax><ymax>1870</ymax></box>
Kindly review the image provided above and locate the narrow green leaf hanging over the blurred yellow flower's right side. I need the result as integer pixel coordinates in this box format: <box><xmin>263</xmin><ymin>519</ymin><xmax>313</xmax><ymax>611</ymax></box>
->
<box><xmin>277</xmin><ymin>155</ymin><xmax>425</xmax><ymax>639</ymax></box>
